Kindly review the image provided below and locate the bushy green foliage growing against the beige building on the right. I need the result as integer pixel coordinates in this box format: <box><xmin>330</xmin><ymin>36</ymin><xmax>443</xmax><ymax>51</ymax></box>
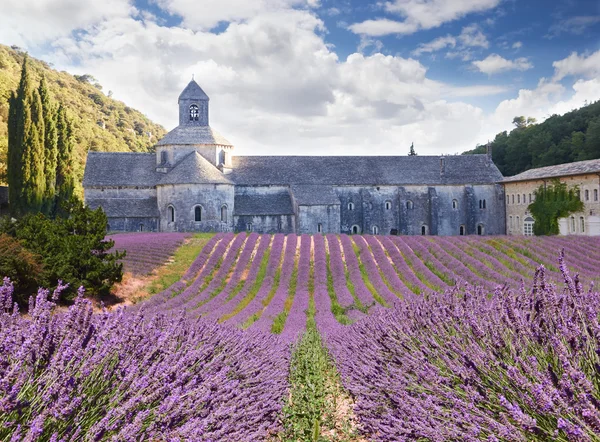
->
<box><xmin>528</xmin><ymin>179</ymin><xmax>583</xmax><ymax>235</ymax></box>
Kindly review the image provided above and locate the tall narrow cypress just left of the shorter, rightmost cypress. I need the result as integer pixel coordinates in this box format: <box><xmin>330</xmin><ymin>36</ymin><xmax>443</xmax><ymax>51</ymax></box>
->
<box><xmin>38</xmin><ymin>77</ymin><xmax>58</xmax><ymax>215</ymax></box>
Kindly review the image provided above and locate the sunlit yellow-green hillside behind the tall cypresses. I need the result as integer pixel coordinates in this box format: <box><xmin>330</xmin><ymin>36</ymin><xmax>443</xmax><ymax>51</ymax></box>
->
<box><xmin>0</xmin><ymin>45</ymin><xmax>166</xmax><ymax>188</ymax></box>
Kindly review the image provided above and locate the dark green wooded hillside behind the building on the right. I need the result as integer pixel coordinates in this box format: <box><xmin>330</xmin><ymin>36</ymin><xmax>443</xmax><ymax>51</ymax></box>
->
<box><xmin>464</xmin><ymin>101</ymin><xmax>600</xmax><ymax>176</ymax></box>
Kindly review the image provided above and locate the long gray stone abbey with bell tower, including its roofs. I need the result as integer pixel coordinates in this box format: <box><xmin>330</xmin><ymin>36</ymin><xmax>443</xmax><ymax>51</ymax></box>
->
<box><xmin>83</xmin><ymin>80</ymin><xmax>506</xmax><ymax>235</ymax></box>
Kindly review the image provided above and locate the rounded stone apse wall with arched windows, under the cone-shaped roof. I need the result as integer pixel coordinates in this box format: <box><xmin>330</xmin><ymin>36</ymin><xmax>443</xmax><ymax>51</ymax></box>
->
<box><xmin>157</xmin><ymin>184</ymin><xmax>234</xmax><ymax>232</ymax></box>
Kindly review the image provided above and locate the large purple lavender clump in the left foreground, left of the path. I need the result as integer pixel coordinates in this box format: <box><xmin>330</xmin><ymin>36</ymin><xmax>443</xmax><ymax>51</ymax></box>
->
<box><xmin>0</xmin><ymin>280</ymin><xmax>289</xmax><ymax>441</ymax></box>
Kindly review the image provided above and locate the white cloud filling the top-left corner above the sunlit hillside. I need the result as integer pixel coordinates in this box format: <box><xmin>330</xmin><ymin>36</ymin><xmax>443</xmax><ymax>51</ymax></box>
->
<box><xmin>0</xmin><ymin>0</ymin><xmax>136</xmax><ymax>46</ymax></box>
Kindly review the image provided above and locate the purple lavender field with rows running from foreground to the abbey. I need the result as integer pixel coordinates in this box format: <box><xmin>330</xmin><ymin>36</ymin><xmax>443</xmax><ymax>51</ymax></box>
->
<box><xmin>0</xmin><ymin>233</ymin><xmax>600</xmax><ymax>441</ymax></box>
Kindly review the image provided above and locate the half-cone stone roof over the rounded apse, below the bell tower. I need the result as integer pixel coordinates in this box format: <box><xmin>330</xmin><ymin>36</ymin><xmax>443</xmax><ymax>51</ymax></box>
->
<box><xmin>158</xmin><ymin>151</ymin><xmax>233</xmax><ymax>185</ymax></box>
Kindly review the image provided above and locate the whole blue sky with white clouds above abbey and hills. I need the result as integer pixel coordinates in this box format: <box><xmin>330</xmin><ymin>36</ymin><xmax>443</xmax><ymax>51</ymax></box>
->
<box><xmin>0</xmin><ymin>0</ymin><xmax>600</xmax><ymax>155</ymax></box>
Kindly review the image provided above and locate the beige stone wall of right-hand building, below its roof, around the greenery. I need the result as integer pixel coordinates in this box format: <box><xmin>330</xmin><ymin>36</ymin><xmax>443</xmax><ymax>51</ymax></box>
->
<box><xmin>504</xmin><ymin>174</ymin><xmax>600</xmax><ymax>235</ymax></box>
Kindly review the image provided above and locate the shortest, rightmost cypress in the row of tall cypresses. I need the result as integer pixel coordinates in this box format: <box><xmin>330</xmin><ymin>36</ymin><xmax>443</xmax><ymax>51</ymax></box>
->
<box><xmin>56</xmin><ymin>105</ymin><xmax>75</xmax><ymax>211</ymax></box>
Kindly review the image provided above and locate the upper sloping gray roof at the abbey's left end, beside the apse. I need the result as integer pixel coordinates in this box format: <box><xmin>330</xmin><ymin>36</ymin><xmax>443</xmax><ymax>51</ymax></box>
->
<box><xmin>83</xmin><ymin>152</ymin><xmax>163</xmax><ymax>187</ymax></box>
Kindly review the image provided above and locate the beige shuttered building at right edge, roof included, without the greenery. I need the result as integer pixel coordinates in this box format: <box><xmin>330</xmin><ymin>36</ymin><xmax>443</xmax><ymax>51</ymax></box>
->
<box><xmin>502</xmin><ymin>159</ymin><xmax>600</xmax><ymax>236</ymax></box>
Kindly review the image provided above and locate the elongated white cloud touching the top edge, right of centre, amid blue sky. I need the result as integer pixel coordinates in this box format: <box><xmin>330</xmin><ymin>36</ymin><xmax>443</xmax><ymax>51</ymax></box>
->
<box><xmin>349</xmin><ymin>0</ymin><xmax>500</xmax><ymax>36</ymax></box>
